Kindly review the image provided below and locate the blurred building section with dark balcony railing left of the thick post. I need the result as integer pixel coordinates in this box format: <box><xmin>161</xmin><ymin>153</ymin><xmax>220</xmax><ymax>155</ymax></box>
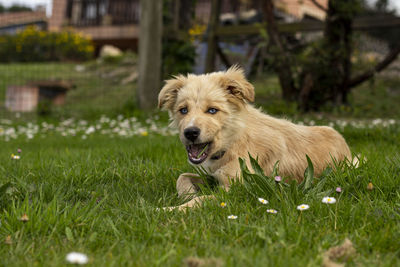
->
<box><xmin>49</xmin><ymin>0</ymin><xmax>139</xmax><ymax>50</ymax></box>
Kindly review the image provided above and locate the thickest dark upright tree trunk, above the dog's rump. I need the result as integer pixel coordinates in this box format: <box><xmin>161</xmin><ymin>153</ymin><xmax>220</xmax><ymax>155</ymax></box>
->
<box><xmin>299</xmin><ymin>0</ymin><xmax>356</xmax><ymax>111</ymax></box>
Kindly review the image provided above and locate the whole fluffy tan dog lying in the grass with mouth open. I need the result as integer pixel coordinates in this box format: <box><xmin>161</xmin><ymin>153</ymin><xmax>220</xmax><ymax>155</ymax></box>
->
<box><xmin>158</xmin><ymin>67</ymin><xmax>351</xmax><ymax>209</ymax></box>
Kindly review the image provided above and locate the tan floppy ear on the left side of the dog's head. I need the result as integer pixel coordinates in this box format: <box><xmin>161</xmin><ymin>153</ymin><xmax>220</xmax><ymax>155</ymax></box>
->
<box><xmin>158</xmin><ymin>75</ymin><xmax>186</xmax><ymax>110</ymax></box>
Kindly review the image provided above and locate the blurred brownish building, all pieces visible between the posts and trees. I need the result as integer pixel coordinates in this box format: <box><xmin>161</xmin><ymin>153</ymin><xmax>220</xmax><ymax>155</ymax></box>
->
<box><xmin>49</xmin><ymin>0</ymin><xmax>327</xmax><ymax>50</ymax></box>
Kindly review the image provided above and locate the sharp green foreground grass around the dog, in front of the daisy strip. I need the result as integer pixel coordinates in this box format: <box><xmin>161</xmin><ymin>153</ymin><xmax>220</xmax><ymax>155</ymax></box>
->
<box><xmin>0</xmin><ymin>125</ymin><xmax>400</xmax><ymax>266</ymax></box>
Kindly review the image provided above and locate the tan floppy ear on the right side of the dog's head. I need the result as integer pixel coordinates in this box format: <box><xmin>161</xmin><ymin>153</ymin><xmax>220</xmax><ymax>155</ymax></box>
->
<box><xmin>220</xmin><ymin>65</ymin><xmax>254</xmax><ymax>102</ymax></box>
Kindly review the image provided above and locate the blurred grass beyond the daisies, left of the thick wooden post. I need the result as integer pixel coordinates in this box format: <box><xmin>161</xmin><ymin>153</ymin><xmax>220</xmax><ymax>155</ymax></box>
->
<box><xmin>0</xmin><ymin>60</ymin><xmax>136</xmax><ymax>119</ymax></box>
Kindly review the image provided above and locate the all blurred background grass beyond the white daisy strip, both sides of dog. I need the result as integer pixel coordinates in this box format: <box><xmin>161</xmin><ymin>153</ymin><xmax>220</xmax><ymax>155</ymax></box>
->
<box><xmin>0</xmin><ymin>60</ymin><xmax>400</xmax><ymax>119</ymax></box>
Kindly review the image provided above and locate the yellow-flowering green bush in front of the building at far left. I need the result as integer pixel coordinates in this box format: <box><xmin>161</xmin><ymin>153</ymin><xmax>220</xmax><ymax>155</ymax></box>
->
<box><xmin>0</xmin><ymin>27</ymin><xmax>94</xmax><ymax>62</ymax></box>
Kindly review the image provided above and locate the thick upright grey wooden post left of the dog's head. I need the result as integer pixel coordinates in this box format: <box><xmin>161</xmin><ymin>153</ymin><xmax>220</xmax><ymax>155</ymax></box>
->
<box><xmin>137</xmin><ymin>0</ymin><xmax>163</xmax><ymax>109</ymax></box>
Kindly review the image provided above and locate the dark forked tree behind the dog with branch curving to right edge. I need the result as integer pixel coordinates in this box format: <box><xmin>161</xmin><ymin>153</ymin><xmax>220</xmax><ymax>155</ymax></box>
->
<box><xmin>263</xmin><ymin>0</ymin><xmax>400</xmax><ymax>111</ymax></box>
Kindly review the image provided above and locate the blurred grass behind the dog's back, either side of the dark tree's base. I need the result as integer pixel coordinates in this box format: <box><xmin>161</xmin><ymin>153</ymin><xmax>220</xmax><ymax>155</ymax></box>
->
<box><xmin>254</xmin><ymin>74</ymin><xmax>400</xmax><ymax>118</ymax></box>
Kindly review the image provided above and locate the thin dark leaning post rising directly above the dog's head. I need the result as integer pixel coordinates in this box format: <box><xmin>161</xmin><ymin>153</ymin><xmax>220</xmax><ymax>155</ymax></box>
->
<box><xmin>204</xmin><ymin>0</ymin><xmax>221</xmax><ymax>73</ymax></box>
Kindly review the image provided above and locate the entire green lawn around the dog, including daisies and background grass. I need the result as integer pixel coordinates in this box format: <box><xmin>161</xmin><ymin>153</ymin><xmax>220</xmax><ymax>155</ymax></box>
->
<box><xmin>0</xmin><ymin>62</ymin><xmax>400</xmax><ymax>266</ymax></box>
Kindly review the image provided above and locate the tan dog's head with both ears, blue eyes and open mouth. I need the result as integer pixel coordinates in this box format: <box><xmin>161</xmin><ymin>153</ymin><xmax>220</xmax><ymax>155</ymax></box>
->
<box><xmin>158</xmin><ymin>67</ymin><xmax>254</xmax><ymax>164</ymax></box>
